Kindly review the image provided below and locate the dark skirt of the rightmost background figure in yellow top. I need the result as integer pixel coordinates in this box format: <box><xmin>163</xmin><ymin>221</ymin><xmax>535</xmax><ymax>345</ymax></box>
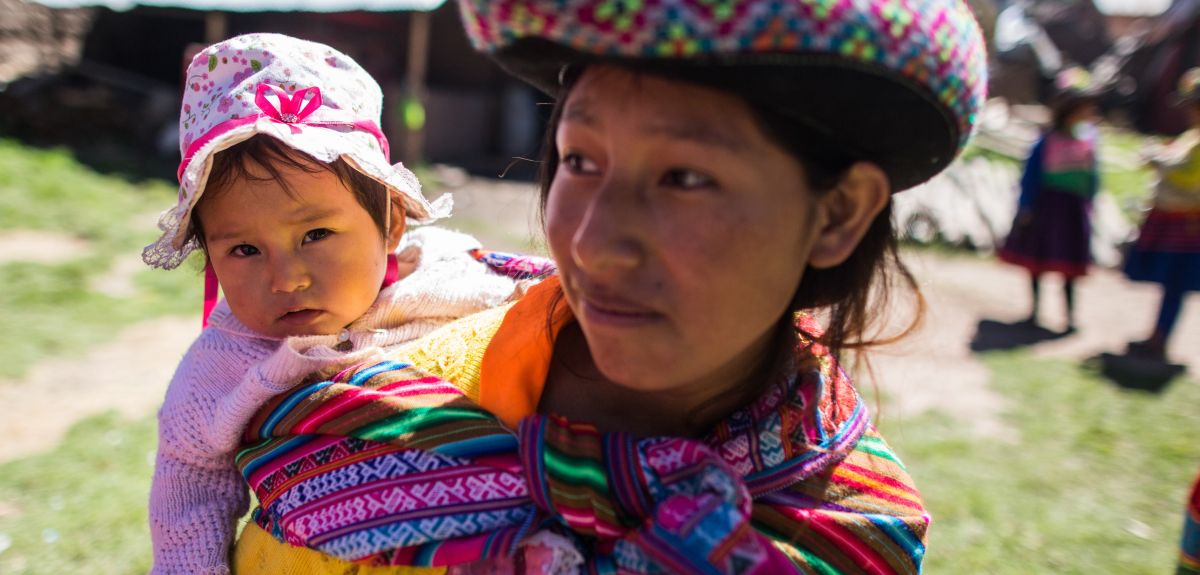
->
<box><xmin>1124</xmin><ymin>208</ymin><xmax>1200</xmax><ymax>291</ymax></box>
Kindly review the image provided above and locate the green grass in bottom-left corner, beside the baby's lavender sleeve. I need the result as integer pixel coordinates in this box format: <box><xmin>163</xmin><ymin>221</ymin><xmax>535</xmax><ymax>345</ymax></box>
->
<box><xmin>0</xmin><ymin>415</ymin><xmax>155</xmax><ymax>575</ymax></box>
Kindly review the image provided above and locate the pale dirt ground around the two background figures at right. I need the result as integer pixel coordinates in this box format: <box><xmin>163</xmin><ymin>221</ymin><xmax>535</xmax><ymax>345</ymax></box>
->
<box><xmin>872</xmin><ymin>251</ymin><xmax>1200</xmax><ymax>438</ymax></box>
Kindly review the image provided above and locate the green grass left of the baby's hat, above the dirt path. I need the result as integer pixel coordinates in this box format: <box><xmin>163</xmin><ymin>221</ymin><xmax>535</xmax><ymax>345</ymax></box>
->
<box><xmin>0</xmin><ymin>139</ymin><xmax>202</xmax><ymax>381</ymax></box>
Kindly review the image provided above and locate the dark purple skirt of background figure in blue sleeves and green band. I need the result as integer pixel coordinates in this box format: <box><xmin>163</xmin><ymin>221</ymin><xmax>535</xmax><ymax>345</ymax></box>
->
<box><xmin>998</xmin><ymin>188</ymin><xmax>1092</xmax><ymax>277</ymax></box>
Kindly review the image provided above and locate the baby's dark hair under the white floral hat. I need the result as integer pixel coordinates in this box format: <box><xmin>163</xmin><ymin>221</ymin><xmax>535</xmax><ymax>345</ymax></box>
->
<box><xmin>187</xmin><ymin>134</ymin><xmax>389</xmax><ymax>248</ymax></box>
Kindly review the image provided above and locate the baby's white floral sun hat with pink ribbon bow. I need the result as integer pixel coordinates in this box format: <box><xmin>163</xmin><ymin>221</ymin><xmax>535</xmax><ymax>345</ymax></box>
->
<box><xmin>142</xmin><ymin>34</ymin><xmax>450</xmax><ymax>269</ymax></box>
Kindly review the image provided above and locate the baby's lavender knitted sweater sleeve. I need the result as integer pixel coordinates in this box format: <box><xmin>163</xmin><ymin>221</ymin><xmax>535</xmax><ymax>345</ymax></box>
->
<box><xmin>150</xmin><ymin>328</ymin><xmax>393</xmax><ymax>574</ymax></box>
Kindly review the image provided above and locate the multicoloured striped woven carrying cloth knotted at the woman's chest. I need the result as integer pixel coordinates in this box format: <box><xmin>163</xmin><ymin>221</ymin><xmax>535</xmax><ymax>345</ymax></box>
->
<box><xmin>231</xmin><ymin>319</ymin><xmax>929</xmax><ymax>574</ymax></box>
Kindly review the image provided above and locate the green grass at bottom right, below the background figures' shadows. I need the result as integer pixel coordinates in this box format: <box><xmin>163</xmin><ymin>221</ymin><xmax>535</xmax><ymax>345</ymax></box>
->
<box><xmin>884</xmin><ymin>352</ymin><xmax>1200</xmax><ymax>575</ymax></box>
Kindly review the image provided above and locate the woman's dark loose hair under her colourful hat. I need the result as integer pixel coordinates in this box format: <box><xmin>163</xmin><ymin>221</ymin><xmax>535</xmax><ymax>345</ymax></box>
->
<box><xmin>539</xmin><ymin>68</ymin><xmax>925</xmax><ymax>420</ymax></box>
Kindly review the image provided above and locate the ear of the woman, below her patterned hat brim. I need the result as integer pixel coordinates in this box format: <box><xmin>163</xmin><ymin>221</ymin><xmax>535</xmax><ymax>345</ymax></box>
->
<box><xmin>809</xmin><ymin>162</ymin><xmax>892</xmax><ymax>269</ymax></box>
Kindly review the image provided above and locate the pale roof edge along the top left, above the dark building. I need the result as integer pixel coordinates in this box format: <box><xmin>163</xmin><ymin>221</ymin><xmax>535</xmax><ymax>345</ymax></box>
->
<box><xmin>34</xmin><ymin>0</ymin><xmax>445</xmax><ymax>12</ymax></box>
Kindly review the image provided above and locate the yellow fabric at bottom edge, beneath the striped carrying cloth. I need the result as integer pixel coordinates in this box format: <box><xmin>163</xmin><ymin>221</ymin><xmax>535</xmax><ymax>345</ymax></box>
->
<box><xmin>233</xmin><ymin>523</ymin><xmax>446</xmax><ymax>575</ymax></box>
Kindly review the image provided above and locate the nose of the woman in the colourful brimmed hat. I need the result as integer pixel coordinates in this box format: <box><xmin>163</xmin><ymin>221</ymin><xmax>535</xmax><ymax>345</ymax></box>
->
<box><xmin>571</xmin><ymin>181</ymin><xmax>644</xmax><ymax>274</ymax></box>
